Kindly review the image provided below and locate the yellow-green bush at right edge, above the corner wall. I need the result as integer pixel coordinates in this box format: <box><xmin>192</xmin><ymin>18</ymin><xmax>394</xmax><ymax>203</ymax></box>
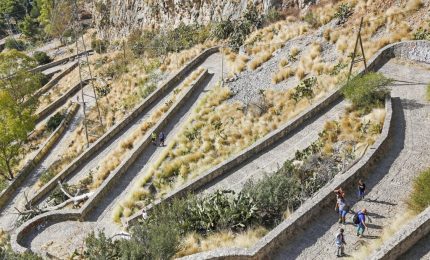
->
<box><xmin>408</xmin><ymin>169</ymin><xmax>430</xmax><ymax>212</ymax></box>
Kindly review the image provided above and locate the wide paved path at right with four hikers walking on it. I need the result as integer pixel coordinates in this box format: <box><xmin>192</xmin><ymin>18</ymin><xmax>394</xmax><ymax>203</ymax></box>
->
<box><xmin>273</xmin><ymin>60</ymin><xmax>430</xmax><ymax>259</ymax></box>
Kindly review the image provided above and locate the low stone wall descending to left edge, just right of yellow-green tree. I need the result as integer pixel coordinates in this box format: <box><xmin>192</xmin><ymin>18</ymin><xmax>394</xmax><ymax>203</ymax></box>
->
<box><xmin>0</xmin><ymin>104</ymin><xmax>79</xmax><ymax>209</ymax></box>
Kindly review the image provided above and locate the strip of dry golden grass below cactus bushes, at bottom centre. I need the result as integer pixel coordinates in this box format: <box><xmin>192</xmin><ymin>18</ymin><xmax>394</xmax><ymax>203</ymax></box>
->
<box><xmin>175</xmin><ymin>227</ymin><xmax>268</xmax><ymax>258</ymax></box>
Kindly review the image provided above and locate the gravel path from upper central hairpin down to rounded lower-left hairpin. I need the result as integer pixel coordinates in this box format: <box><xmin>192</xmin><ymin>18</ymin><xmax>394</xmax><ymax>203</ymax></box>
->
<box><xmin>23</xmin><ymin>53</ymin><xmax>227</xmax><ymax>258</ymax></box>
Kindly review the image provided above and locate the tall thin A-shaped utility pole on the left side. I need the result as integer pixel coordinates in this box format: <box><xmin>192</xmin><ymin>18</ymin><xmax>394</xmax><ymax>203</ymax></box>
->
<box><xmin>73</xmin><ymin>0</ymin><xmax>104</xmax><ymax>147</ymax></box>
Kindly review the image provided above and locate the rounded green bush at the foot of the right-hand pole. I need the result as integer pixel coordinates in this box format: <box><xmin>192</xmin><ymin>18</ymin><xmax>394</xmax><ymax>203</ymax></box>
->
<box><xmin>341</xmin><ymin>72</ymin><xmax>392</xmax><ymax>112</ymax></box>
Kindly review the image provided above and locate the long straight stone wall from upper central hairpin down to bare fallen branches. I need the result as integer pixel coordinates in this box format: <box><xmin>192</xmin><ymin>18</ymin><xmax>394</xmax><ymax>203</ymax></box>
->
<box><xmin>24</xmin><ymin>47</ymin><xmax>219</xmax><ymax>205</ymax></box>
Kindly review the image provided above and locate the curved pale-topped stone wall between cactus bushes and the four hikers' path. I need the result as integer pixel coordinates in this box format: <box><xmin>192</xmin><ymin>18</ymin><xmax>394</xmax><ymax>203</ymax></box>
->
<box><xmin>181</xmin><ymin>97</ymin><xmax>393</xmax><ymax>260</ymax></box>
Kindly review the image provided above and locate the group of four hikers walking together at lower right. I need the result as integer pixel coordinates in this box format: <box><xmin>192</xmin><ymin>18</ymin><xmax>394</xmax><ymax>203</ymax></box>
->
<box><xmin>334</xmin><ymin>180</ymin><xmax>367</xmax><ymax>257</ymax></box>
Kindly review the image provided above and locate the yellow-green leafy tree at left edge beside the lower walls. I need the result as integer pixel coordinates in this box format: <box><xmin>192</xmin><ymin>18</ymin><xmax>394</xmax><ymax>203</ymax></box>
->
<box><xmin>0</xmin><ymin>90</ymin><xmax>34</xmax><ymax>180</ymax></box>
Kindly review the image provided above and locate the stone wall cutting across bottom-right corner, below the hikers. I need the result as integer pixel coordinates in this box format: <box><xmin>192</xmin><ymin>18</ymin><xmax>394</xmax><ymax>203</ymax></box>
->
<box><xmin>370</xmin><ymin>207</ymin><xmax>430</xmax><ymax>260</ymax></box>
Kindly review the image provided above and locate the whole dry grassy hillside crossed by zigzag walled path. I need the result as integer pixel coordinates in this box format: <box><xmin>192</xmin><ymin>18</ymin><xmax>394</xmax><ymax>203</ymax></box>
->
<box><xmin>0</xmin><ymin>0</ymin><xmax>430</xmax><ymax>259</ymax></box>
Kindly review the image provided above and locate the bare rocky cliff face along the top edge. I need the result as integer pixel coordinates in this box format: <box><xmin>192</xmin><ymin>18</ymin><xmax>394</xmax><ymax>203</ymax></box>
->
<box><xmin>94</xmin><ymin>0</ymin><xmax>315</xmax><ymax>38</ymax></box>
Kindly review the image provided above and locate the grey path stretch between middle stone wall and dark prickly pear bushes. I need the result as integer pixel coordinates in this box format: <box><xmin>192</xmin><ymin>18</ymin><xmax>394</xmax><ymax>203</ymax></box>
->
<box><xmin>200</xmin><ymin>98</ymin><xmax>346</xmax><ymax>193</ymax></box>
